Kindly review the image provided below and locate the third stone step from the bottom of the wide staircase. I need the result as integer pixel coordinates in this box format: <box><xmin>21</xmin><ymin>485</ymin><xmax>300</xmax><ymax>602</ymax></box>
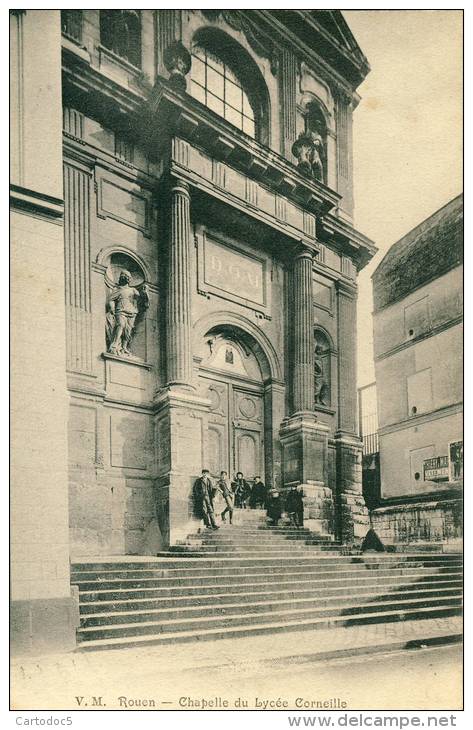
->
<box><xmin>80</xmin><ymin>585</ymin><xmax>462</xmax><ymax>626</ymax></box>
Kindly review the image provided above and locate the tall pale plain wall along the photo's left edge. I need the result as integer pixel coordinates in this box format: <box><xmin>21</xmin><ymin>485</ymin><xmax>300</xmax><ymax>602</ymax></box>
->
<box><xmin>10</xmin><ymin>10</ymin><xmax>78</xmax><ymax>653</ymax></box>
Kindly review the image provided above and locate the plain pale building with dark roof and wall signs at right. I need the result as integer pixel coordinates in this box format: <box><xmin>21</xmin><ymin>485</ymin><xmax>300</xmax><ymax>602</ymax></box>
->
<box><xmin>372</xmin><ymin>195</ymin><xmax>463</xmax><ymax>542</ymax></box>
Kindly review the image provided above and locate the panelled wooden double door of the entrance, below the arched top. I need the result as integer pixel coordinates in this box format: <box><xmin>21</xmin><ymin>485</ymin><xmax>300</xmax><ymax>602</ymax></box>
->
<box><xmin>201</xmin><ymin>375</ymin><xmax>264</xmax><ymax>481</ymax></box>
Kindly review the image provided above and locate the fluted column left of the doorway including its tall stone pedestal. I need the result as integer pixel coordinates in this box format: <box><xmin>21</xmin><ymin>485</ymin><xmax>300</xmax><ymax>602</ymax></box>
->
<box><xmin>153</xmin><ymin>177</ymin><xmax>210</xmax><ymax>545</ymax></box>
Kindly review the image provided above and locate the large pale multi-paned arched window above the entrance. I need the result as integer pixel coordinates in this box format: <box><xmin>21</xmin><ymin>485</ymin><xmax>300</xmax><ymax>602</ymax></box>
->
<box><xmin>190</xmin><ymin>45</ymin><xmax>256</xmax><ymax>137</ymax></box>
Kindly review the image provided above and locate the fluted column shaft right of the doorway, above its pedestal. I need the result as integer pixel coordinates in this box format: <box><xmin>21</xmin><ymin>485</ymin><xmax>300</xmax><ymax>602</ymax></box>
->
<box><xmin>292</xmin><ymin>246</ymin><xmax>314</xmax><ymax>414</ymax></box>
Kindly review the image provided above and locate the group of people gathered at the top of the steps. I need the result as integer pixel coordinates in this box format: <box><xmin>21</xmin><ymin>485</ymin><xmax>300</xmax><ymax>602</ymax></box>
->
<box><xmin>193</xmin><ymin>469</ymin><xmax>304</xmax><ymax>530</ymax></box>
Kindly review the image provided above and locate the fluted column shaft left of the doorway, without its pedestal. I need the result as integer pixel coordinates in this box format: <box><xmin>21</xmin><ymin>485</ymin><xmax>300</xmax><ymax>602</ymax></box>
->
<box><xmin>166</xmin><ymin>179</ymin><xmax>193</xmax><ymax>388</ymax></box>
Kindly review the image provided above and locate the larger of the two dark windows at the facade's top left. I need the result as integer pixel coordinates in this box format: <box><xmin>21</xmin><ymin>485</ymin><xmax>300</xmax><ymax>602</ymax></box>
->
<box><xmin>100</xmin><ymin>10</ymin><xmax>141</xmax><ymax>68</ymax></box>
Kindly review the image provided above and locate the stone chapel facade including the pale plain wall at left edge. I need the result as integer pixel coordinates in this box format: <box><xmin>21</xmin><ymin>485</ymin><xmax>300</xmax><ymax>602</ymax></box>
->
<box><xmin>11</xmin><ymin>10</ymin><xmax>376</xmax><ymax>650</ymax></box>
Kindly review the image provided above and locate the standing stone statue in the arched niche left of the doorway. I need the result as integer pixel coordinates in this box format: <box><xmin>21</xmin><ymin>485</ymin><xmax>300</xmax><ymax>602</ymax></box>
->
<box><xmin>105</xmin><ymin>269</ymin><xmax>149</xmax><ymax>357</ymax></box>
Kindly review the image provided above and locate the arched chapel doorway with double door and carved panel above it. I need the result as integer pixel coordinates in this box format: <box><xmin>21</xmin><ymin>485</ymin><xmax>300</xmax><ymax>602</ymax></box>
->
<box><xmin>199</xmin><ymin>327</ymin><xmax>265</xmax><ymax>480</ymax></box>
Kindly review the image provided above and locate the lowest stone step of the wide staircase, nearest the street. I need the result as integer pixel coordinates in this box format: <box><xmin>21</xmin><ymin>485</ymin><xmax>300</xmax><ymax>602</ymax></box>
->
<box><xmin>78</xmin><ymin>606</ymin><xmax>461</xmax><ymax>650</ymax></box>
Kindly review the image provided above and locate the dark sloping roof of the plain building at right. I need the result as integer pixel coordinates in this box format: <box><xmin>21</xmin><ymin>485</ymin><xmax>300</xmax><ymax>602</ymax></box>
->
<box><xmin>372</xmin><ymin>195</ymin><xmax>463</xmax><ymax>312</ymax></box>
